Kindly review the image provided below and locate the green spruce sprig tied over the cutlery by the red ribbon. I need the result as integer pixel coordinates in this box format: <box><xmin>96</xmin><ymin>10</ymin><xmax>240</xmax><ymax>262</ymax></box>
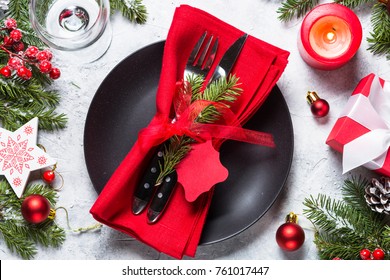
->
<box><xmin>156</xmin><ymin>75</ymin><xmax>242</xmax><ymax>185</ymax></box>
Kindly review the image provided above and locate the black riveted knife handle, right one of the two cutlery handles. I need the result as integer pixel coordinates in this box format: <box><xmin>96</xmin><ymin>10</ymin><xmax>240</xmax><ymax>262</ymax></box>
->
<box><xmin>147</xmin><ymin>170</ymin><xmax>177</xmax><ymax>223</ymax></box>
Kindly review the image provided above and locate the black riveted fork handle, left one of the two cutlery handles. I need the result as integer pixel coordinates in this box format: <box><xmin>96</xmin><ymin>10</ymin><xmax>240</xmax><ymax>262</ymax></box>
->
<box><xmin>132</xmin><ymin>145</ymin><xmax>164</xmax><ymax>214</ymax></box>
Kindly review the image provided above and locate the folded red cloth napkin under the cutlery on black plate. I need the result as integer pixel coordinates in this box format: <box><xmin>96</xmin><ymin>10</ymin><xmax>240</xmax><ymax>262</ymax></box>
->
<box><xmin>91</xmin><ymin>5</ymin><xmax>289</xmax><ymax>259</ymax></box>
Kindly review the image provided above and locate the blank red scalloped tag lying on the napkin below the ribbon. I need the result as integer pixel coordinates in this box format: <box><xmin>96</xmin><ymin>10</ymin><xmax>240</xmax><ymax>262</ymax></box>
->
<box><xmin>176</xmin><ymin>141</ymin><xmax>229</xmax><ymax>202</ymax></box>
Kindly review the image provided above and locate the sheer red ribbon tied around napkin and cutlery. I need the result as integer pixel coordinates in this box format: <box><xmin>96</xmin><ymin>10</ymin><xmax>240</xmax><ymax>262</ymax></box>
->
<box><xmin>138</xmin><ymin>82</ymin><xmax>275</xmax><ymax>148</ymax></box>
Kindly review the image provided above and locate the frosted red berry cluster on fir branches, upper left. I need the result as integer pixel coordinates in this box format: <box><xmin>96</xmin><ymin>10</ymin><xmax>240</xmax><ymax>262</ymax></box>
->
<box><xmin>0</xmin><ymin>18</ymin><xmax>61</xmax><ymax>80</ymax></box>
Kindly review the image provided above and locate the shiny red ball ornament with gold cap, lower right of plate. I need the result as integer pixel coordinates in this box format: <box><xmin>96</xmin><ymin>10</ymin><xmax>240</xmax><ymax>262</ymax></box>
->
<box><xmin>276</xmin><ymin>213</ymin><xmax>305</xmax><ymax>251</ymax></box>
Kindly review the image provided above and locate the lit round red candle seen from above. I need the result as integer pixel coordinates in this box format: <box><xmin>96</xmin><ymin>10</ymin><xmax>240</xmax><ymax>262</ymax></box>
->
<box><xmin>298</xmin><ymin>3</ymin><xmax>362</xmax><ymax>70</ymax></box>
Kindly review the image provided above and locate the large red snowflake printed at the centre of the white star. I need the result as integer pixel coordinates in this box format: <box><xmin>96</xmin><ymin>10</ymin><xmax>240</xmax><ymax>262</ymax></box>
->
<box><xmin>0</xmin><ymin>137</ymin><xmax>34</xmax><ymax>174</ymax></box>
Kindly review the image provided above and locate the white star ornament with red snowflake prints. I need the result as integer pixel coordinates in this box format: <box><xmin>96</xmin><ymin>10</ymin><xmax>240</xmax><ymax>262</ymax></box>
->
<box><xmin>0</xmin><ymin>118</ymin><xmax>56</xmax><ymax>198</ymax></box>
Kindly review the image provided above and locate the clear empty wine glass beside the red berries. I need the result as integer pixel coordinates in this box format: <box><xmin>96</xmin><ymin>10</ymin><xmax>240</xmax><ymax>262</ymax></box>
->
<box><xmin>29</xmin><ymin>0</ymin><xmax>112</xmax><ymax>62</ymax></box>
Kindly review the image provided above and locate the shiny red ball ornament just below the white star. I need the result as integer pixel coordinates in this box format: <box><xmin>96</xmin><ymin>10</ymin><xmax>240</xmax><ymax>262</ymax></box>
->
<box><xmin>22</xmin><ymin>194</ymin><xmax>50</xmax><ymax>224</ymax></box>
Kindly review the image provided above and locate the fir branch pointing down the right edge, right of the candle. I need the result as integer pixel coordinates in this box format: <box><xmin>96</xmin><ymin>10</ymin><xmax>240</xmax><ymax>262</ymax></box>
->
<box><xmin>367</xmin><ymin>3</ymin><xmax>390</xmax><ymax>60</ymax></box>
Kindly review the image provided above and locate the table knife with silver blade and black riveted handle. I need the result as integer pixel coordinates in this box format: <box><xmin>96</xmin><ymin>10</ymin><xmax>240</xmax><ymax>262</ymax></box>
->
<box><xmin>147</xmin><ymin>34</ymin><xmax>248</xmax><ymax>223</ymax></box>
